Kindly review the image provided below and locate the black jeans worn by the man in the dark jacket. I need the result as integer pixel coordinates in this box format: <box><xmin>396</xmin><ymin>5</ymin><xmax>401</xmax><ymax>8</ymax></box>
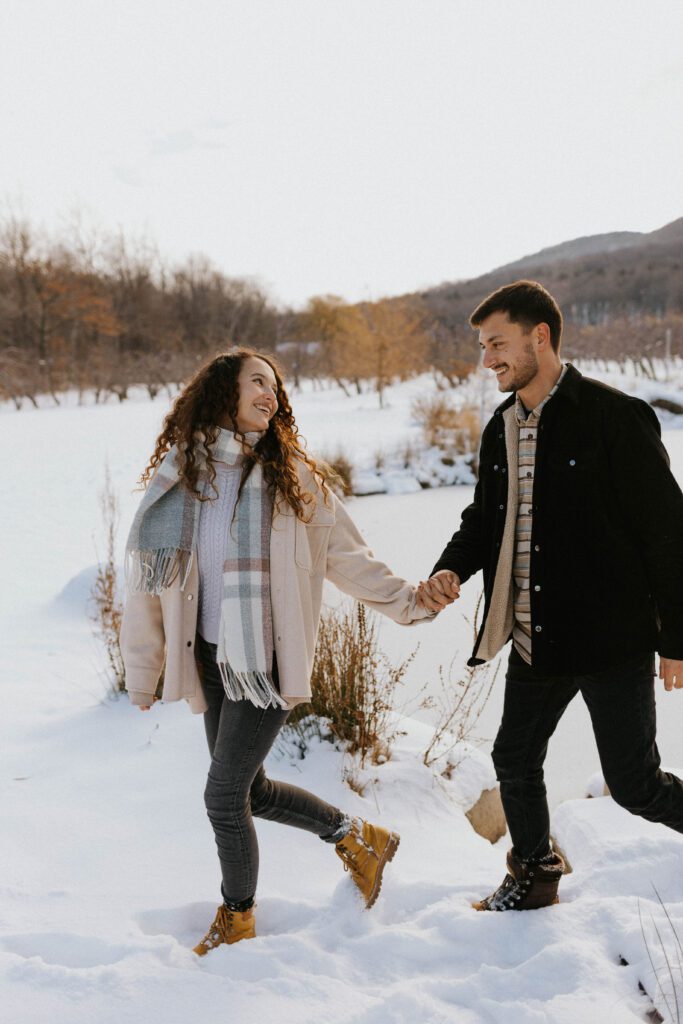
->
<box><xmin>492</xmin><ymin>647</ymin><xmax>683</xmax><ymax>860</ymax></box>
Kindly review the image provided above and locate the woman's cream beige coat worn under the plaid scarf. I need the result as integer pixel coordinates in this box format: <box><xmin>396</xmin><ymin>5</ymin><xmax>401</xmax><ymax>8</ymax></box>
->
<box><xmin>121</xmin><ymin>479</ymin><xmax>433</xmax><ymax>713</ymax></box>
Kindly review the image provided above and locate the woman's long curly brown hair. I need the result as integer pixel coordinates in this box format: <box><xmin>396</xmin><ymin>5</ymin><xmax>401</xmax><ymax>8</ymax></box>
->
<box><xmin>140</xmin><ymin>348</ymin><xmax>330</xmax><ymax>521</ymax></box>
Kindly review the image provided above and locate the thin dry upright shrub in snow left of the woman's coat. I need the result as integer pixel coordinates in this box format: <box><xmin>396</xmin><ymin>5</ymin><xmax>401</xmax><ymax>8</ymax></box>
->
<box><xmin>91</xmin><ymin>464</ymin><xmax>126</xmax><ymax>694</ymax></box>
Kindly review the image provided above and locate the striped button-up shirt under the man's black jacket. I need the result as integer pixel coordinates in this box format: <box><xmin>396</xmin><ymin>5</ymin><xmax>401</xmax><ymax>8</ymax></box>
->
<box><xmin>512</xmin><ymin>366</ymin><xmax>567</xmax><ymax>665</ymax></box>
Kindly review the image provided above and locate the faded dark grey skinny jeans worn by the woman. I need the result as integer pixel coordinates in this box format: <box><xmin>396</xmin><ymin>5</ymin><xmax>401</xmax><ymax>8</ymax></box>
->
<box><xmin>197</xmin><ymin>634</ymin><xmax>349</xmax><ymax>909</ymax></box>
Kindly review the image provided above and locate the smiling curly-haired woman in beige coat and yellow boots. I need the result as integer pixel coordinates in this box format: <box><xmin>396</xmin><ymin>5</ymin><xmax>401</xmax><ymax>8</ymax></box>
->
<box><xmin>121</xmin><ymin>349</ymin><xmax>430</xmax><ymax>955</ymax></box>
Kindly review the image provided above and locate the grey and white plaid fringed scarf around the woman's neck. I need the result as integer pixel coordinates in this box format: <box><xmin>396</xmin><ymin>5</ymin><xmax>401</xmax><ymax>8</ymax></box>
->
<box><xmin>126</xmin><ymin>428</ymin><xmax>287</xmax><ymax>708</ymax></box>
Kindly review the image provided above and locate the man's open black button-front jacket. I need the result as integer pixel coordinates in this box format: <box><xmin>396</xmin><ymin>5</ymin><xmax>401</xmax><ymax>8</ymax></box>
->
<box><xmin>432</xmin><ymin>366</ymin><xmax>683</xmax><ymax>676</ymax></box>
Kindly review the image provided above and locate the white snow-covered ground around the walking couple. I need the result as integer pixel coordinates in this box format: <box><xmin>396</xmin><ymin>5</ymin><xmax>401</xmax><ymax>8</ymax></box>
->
<box><xmin>0</xmin><ymin>374</ymin><xmax>683</xmax><ymax>1024</ymax></box>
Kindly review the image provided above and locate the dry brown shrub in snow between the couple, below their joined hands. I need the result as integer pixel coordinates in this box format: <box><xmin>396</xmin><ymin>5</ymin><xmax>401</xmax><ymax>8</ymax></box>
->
<box><xmin>287</xmin><ymin>602</ymin><xmax>417</xmax><ymax>767</ymax></box>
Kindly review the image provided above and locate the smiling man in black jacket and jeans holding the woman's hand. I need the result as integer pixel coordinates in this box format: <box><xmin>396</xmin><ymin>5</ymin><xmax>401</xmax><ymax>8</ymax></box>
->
<box><xmin>420</xmin><ymin>281</ymin><xmax>683</xmax><ymax>910</ymax></box>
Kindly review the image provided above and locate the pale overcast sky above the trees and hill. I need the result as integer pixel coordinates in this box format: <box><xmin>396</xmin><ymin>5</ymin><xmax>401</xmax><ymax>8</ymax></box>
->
<box><xmin>0</xmin><ymin>0</ymin><xmax>683</xmax><ymax>305</ymax></box>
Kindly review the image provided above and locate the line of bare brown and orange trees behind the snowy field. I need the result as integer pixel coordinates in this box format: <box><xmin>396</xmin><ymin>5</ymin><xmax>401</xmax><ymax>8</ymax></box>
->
<box><xmin>0</xmin><ymin>216</ymin><xmax>683</xmax><ymax>408</ymax></box>
